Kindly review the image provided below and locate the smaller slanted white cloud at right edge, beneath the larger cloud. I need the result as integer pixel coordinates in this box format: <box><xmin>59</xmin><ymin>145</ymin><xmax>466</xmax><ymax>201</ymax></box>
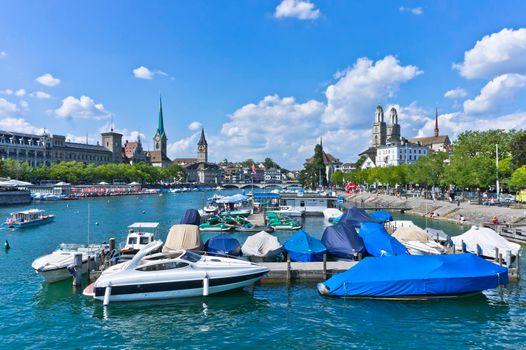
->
<box><xmin>464</xmin><ymin>74</ymin><xmax>526</xmax><ymax>114</ymax></box>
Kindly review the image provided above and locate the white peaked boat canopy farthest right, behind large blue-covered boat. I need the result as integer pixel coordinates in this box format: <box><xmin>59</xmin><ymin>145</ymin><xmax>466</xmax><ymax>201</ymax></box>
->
<box><xmin>451</xmin><ymin>226</ymin><xmax>521</xmax><ymax>258</ymax></box>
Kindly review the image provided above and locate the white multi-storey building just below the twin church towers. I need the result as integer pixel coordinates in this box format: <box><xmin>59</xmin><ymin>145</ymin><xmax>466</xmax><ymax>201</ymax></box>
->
<box><xmin>375</xmin><ymin>139</ymin><xmax>428</xmax><ymax>167</ymax></box>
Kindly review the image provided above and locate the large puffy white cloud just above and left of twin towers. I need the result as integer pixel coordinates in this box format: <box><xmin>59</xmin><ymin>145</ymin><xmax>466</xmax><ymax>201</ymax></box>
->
<box><xmin>323</xmin><ymin>56</ymin><xmax>422</xmax><ymax>128</ymax></box>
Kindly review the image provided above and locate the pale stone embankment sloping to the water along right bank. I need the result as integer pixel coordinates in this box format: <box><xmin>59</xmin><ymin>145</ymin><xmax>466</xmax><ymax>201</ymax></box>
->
<box><xmin>345</xmin><ymin>192</ymin><xmax>526</xmax><ymax>226</ymax></box>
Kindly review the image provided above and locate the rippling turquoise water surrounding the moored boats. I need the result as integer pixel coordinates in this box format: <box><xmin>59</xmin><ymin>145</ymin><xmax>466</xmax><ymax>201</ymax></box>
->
<box><xmin>0</xmin><ymin>193</ymin><xmax>526</xmax><ymax>349</ymax></box>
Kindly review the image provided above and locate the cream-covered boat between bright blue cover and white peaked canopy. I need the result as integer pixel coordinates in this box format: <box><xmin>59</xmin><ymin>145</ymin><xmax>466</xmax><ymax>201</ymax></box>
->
<box><xmin>393</xmin><ymin>226</ymin><xmax>446</xmax><ymax>255</ymax></box>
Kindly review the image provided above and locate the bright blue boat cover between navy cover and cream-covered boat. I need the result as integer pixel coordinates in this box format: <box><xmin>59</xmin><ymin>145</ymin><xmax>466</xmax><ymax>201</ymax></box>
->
<box><xmin>358</xmin><ymin>222</ymin><xmax>407</xmax><ymax>256</ymax></box>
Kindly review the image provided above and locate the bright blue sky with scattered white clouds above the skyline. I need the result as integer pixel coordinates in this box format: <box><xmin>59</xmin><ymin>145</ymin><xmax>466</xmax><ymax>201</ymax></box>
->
<box><xmin>0</xmin><ymin>0</ymin><xmax>526</xmax><ymax>169</ymax></box>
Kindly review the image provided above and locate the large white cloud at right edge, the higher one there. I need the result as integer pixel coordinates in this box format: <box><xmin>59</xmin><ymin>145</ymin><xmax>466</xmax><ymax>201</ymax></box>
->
<box><xmin>453</xmin><ymin>28</ymin><xmax>526</xmax><ymax>79</ymax></box>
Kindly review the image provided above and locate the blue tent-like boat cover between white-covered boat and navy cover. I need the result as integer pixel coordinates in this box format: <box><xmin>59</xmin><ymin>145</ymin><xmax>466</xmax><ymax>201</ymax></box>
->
<box><xmin>283</xmin><ymin>230</ymin><xmax>327</xmax><ymax>261</ymax></box>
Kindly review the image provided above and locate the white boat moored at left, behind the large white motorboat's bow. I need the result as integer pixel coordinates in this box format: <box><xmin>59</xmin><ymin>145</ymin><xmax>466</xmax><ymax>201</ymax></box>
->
<box><xmin>31</xmin><ymin>243</ymin><xmax>108</xmax><ymax>283</ymax></box>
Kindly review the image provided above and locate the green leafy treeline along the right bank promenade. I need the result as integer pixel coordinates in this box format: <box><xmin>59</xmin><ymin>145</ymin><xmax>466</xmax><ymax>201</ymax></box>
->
<box><xmin>331</xmin><ymin>130</ymin><xmax>526</xmax><ymax>190</ymax></box>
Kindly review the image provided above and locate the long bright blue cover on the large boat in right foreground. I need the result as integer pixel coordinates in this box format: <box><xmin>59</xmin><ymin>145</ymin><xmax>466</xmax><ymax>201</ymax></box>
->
<box><xmin>323</xmin><ymin>253</ymin><xmax>508</xmax><ymax>297</ymax></box>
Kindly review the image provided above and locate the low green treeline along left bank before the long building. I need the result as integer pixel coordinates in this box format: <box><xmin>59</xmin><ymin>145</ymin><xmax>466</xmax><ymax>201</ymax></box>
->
<box><xmin>0</xmin><ymin>159</ymin><xmax>185</xmax><ymax>184</ymax></box>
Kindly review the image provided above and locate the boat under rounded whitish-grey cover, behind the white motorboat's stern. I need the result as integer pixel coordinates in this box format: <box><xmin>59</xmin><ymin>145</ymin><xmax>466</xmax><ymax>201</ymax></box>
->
<box><xmin>241</xmin><ymin>231</ymin><xmax>283</xmax><ymax>261</ymax></box>
